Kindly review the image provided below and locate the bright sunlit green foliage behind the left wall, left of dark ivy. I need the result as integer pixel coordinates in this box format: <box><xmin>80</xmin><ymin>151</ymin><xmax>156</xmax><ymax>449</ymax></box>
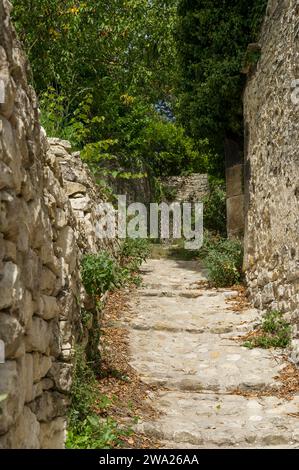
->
<box><xmin>13</xmin><ymin>0</ymin><xmax>213</xmax><ymax>182</ymax></box>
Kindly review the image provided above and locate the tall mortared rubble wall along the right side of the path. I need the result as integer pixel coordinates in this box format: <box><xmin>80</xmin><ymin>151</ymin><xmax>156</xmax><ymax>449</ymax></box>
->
<box><xmin>244</xmin><ymin>0</ymin><xmax>299</xmax><ymax>361</ymax></box>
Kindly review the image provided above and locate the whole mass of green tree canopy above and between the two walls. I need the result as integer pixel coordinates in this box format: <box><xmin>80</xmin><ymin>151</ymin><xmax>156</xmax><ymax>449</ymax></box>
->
<box><xmin>13</xmin><ymin>0</ymin><xmax>266</xmax><ymax>182</ymax></box>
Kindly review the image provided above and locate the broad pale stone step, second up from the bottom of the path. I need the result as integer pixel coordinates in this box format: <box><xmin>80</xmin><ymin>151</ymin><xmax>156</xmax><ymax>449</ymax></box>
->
<box><xmin>129</xmin><ymin>330</ymin><xmax>284</xmax><ymax>392</ymax></box>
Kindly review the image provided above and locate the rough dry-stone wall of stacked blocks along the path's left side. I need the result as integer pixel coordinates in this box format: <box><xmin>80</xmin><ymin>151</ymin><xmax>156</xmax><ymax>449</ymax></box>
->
<box><xmin>0</xmin><ymin>0</ymin><xmax>115</xmax><ymax>448</ymax></box>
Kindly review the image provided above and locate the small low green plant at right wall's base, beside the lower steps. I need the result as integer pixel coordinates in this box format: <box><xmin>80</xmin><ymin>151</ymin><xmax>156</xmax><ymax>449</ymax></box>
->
<box><xmin>243</xmin><ymin>310</ymin><xmax>291</xmax><ymax>349</ymax></box>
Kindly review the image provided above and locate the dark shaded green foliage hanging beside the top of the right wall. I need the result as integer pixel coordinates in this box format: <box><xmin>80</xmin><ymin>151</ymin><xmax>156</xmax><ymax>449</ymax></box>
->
<box><xmin>177</xmin><ymin>0</ymin><xmax>267</xmax><ymax>165</ymax></box>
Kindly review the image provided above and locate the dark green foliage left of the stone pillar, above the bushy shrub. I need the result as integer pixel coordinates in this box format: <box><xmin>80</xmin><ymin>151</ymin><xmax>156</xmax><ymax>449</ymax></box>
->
<box><xmin>203</xmin><ymin>178</ymin><xmax>227</xmax><ymax>237</ymax></box>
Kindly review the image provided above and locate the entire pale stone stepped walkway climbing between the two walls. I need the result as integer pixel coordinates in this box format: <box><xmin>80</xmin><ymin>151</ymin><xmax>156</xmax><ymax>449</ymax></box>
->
<box><xmin>125</xmin><ymin>259</ymin><xmax>299</xmax><ymax>449</ymax></box>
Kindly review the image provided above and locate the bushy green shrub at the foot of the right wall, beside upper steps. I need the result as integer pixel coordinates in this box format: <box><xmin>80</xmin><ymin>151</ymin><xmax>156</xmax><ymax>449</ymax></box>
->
<box><xmin>200</xmin><ymin>234</ymin><xmax>243</xmax><ymax>287</ymax></box>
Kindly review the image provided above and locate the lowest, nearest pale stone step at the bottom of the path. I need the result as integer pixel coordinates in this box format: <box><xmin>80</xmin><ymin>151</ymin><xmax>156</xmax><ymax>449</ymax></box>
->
<box><xmin>139</xmin><ymin>392</ymin><xmax>299</xmax><ymax>449</ymax></box>
